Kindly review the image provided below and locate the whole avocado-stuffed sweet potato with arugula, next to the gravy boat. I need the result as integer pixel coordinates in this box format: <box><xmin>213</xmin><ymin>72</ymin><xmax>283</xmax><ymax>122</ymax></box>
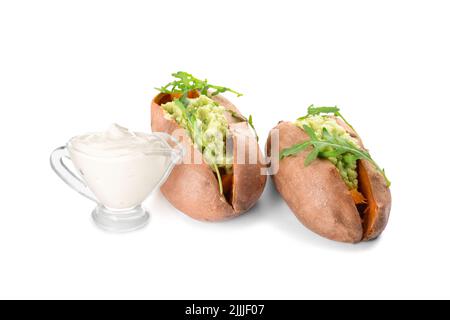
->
<box><xmin>151</xmin><ymin>72</ymin><xmax>266</xmax><ymax>221</ymax></box>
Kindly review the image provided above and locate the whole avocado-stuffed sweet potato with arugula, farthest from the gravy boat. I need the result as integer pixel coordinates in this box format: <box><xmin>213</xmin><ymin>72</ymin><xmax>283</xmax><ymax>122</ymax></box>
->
<box><xmin>267</xmin><ymin>106</ymin><xmax>391</xmax><ymax>243</ymax></box>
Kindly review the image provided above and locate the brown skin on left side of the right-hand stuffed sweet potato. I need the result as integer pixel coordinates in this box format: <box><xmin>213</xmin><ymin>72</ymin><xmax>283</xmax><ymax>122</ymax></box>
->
<box><xmin>267</xmin><ymin>122</ymin><xmax>363</xmax><ymax>243</ymax></box>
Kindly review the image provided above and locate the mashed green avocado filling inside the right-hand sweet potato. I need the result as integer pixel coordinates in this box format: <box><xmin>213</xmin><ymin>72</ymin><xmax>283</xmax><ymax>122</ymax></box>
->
<box><xmin>295</xmin><ymin>115</ymin><xmax>360</xmax><ymax>190</ymax></box>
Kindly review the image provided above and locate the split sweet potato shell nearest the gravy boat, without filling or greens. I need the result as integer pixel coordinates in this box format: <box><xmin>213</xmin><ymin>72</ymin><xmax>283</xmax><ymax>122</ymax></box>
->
<box><xmin>151</xmin><ymin>93</ymin><xmax>267</xmax><ymax>221</ymax></box>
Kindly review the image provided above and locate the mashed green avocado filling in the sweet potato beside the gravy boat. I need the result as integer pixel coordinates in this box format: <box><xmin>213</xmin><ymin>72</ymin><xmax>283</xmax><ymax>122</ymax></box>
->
<box><xmin>162</xmin><ymin>95</ymin><xmax>233</xmax><ymax>173</ymax></box>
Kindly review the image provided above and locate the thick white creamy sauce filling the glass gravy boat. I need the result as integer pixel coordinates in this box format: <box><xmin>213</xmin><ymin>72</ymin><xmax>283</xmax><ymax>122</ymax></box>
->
<box><xmin>68</xmin><ymin>124</ymin><xmax>171</xmax><ymax>209</ymax></box>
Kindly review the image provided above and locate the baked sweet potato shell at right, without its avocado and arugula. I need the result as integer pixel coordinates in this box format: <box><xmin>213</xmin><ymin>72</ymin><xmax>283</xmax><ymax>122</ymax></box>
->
<box><xmin>267</xmin><ymin>121</ymin><xmax>391</xmax><ymax>243</ymax></box>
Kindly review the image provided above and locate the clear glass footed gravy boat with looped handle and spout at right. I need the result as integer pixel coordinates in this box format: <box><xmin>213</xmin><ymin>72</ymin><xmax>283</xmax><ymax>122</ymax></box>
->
<box><xmin>50</xmin><ymin>132</ymin><xmax>185</xmax><ymax>232</ymax></box>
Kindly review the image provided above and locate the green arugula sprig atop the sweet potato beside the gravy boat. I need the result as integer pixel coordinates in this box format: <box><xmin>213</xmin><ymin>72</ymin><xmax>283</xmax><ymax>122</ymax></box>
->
<box><xmin>156</xmin><ymin>71</ymin><xmax>242</xmax><ymax>97</ymax></box>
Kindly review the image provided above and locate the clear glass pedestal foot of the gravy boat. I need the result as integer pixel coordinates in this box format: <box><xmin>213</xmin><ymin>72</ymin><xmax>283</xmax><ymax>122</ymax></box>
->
<box><xmin>92</xmin><ymin>205</ymin><xmax>150</xmax><ymax>232</ymax></box>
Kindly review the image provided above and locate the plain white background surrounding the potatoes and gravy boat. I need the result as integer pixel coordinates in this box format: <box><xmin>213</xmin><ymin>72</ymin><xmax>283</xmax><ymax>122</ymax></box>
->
<box><xmin>0</xmin><ymin>0</ymin><xmax>450</xmax><ymax>299</ymax></box>
